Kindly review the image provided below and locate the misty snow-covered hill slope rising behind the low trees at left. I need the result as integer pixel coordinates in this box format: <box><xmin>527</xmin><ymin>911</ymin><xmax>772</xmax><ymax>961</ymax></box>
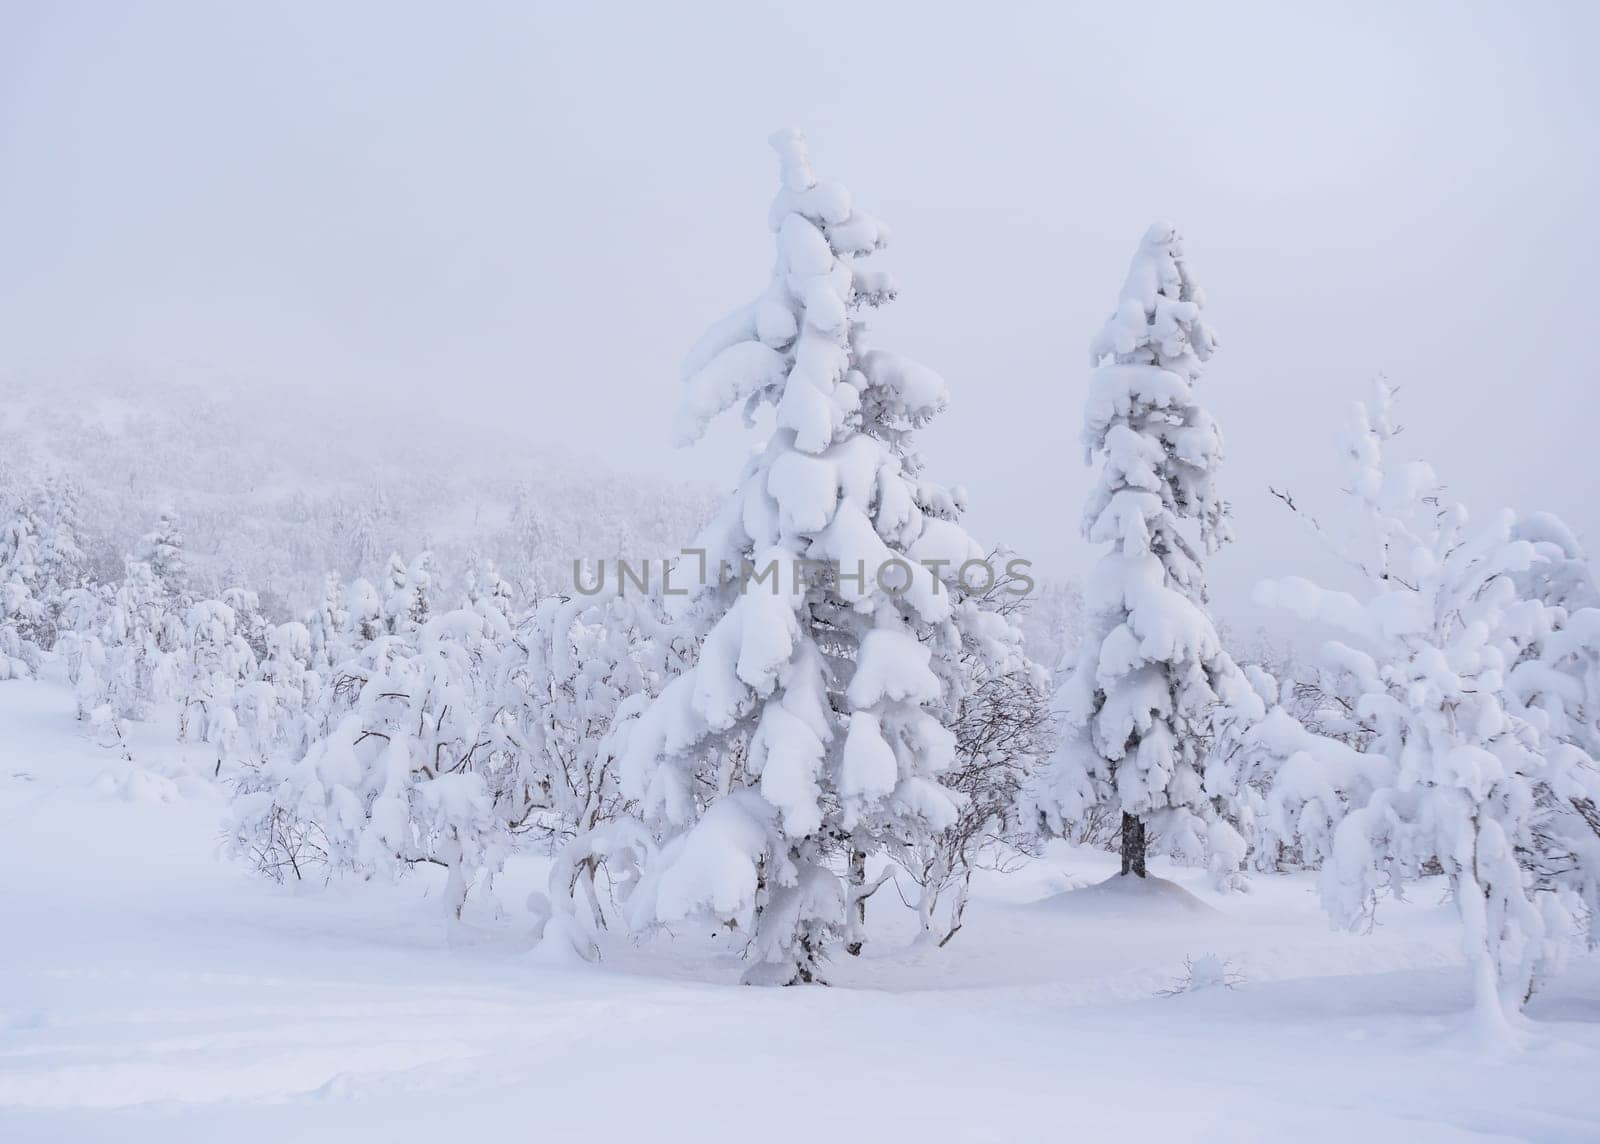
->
<box><xmin>0</xmin><ymin>378</ymin><xmax>714</xmax><ymax>614</ymax></box>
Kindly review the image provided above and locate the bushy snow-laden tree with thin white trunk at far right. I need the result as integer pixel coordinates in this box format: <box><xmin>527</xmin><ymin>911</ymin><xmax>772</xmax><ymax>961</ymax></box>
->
<box><xmin>1261</xmin><ymin>382</ymin><xmax>1600</xmax><ymax>1034</ymax></box>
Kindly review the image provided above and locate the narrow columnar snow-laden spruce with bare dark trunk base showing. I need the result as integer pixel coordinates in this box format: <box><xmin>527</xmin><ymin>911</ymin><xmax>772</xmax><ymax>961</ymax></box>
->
<box><xmin>1037</xmin><ymin>222</ymin><xmax>1253</xmax><ymax>880</ymax></box>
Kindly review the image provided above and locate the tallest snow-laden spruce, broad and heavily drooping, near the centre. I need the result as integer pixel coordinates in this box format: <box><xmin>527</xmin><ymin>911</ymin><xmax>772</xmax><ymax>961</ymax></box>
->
<box><xmin>622</xmin><ymin>131</ymin><xmax>1018</xmax><ymax>984</ymax></box>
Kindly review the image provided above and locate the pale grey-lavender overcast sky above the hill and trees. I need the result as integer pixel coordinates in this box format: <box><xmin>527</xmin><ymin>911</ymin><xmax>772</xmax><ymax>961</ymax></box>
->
<box><xmin>0</xmin><ymin>0</ymin><xmax>1600</xmax><ymax>627</ymax></box>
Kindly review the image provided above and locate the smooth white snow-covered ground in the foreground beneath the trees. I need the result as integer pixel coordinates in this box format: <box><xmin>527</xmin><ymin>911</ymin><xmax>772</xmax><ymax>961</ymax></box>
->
<box><xmin>9</xmin><ymin>682</ymin><xmax>1600</xmax><ymax>1144</ymax></box>
